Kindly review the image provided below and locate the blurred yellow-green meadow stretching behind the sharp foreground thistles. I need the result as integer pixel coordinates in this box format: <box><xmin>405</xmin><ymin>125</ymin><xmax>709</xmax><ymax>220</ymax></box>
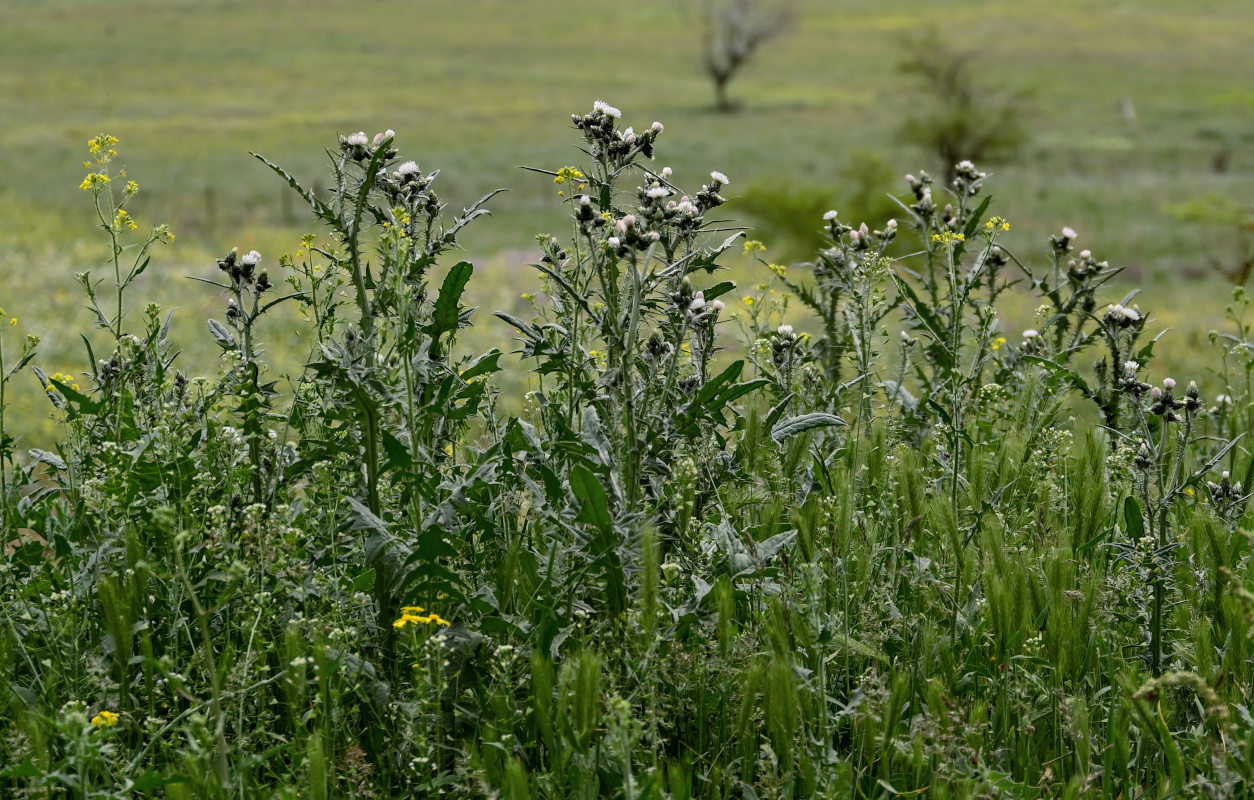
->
<box><xmin>0</xmin><ymin>0</ymin><xmax>1254</xmax><ymax>446</ymax></box>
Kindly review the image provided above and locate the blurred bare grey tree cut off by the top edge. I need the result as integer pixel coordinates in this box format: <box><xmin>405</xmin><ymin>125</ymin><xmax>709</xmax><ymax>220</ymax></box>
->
<box><xmin>702</xmin><ymin>0</ymin><xmax>795</xmax><ymax>112</ymax></box>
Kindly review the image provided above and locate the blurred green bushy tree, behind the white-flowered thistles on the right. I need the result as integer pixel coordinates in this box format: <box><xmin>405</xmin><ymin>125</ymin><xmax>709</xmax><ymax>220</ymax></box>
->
<box><xmin>900</xmin><ymin>35</ymin><xmax>1027</xmax><ymax>182</ymax></box>
